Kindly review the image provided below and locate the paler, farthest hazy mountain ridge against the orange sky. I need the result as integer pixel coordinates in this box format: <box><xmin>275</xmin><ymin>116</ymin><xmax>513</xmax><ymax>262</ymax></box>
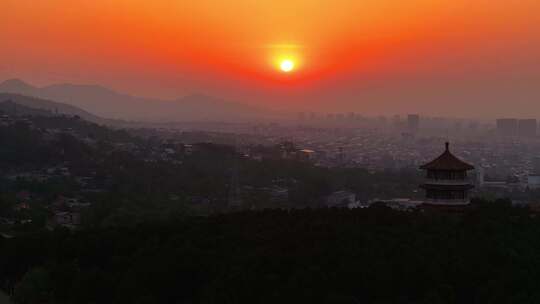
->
<box><xmin>0</xmin><ymin>79</ymin><xmax>268</xmax><ymax>122</ymax></box>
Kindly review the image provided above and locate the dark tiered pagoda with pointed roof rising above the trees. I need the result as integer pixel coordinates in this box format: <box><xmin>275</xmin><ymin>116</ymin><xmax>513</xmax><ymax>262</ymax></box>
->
<box><xmin>420</xmin><ymin>142</ymin><xmax>474</xmax><ymax>206</ymax></box>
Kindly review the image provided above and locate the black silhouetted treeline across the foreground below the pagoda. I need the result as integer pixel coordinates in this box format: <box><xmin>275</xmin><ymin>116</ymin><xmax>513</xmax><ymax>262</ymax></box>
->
<box><xmin>0</xmin><ymin>201</ymin><xmax>540</xmax><ymax>303</ymax></box>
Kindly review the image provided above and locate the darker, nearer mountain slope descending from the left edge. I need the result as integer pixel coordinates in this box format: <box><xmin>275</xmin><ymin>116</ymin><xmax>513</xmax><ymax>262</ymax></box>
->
<box><xmin>0</xmin><ymin>93</ymin><xmax>107</xmax><ymax>124</ymax></box>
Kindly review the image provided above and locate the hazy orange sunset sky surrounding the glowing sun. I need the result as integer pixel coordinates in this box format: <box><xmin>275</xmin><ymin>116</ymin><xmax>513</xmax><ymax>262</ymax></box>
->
<box><xmin>0</xmin><ymin>0</ymin><xmax>540</xmax><ymax>118</ymax></box>
